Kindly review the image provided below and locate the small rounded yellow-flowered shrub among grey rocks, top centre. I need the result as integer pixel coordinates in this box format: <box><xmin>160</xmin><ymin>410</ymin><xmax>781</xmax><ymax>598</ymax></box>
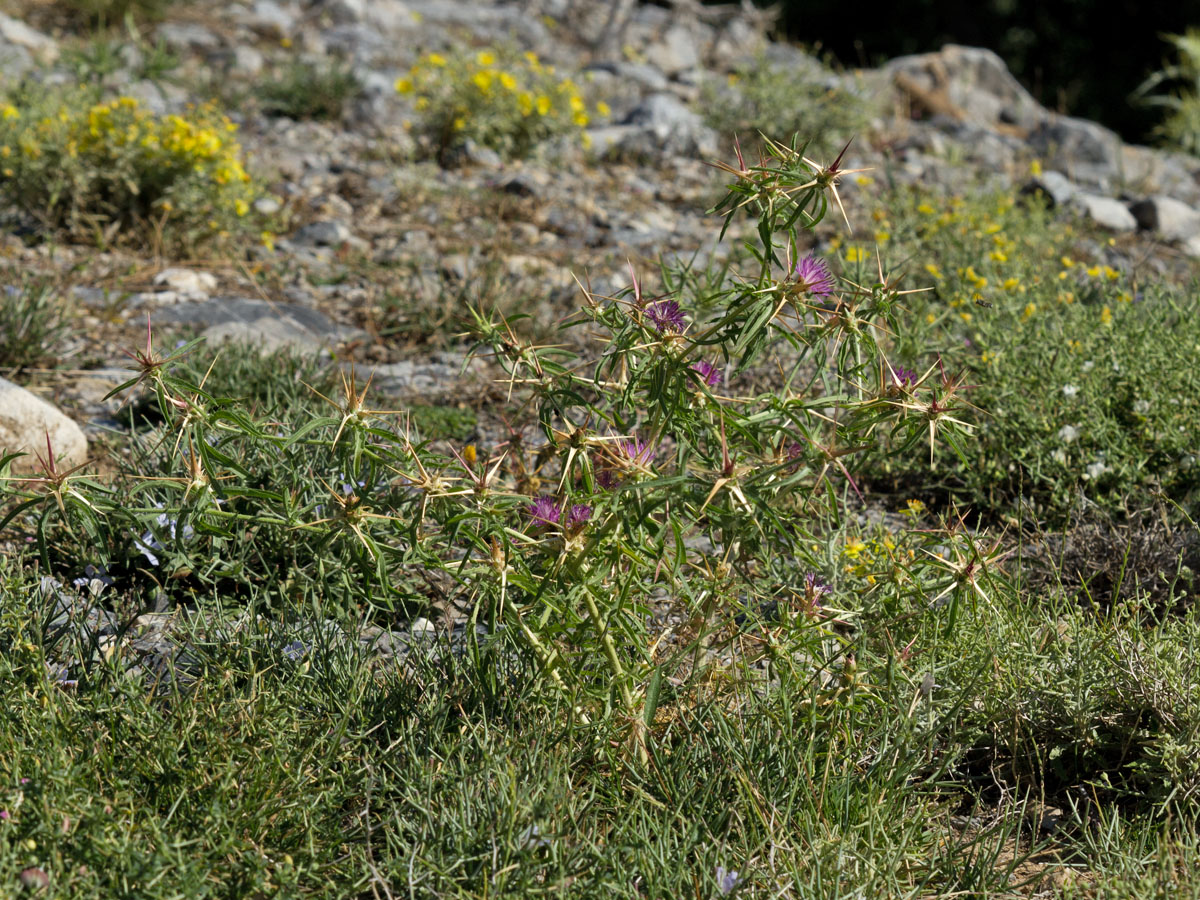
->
<box><xmin>396</xmin><ymin>50</ymin><xmax>608</xmax><ymax>157</ymax></box>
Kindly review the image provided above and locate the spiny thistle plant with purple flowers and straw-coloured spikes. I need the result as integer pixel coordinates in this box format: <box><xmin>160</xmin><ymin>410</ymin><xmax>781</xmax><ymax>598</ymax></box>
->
<box><xmin>0</xmin><ymin>135</ymin><xmax>998</xmax><ymax>760</ymax></box>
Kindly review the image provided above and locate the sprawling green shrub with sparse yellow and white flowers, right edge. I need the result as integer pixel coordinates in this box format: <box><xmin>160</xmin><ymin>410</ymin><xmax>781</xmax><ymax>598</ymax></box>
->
<box><xmin>842</xmin><ymin>184</ymin><xmax>1200</xmax><ymax>523</ymax></box>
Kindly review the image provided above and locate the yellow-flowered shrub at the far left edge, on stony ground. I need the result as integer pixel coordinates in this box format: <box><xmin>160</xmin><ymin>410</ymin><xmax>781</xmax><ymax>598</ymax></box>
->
<box><xmin>0</xmin><ymin>88</ymin><xmax>254</xmax><ymax>246</ymax></box>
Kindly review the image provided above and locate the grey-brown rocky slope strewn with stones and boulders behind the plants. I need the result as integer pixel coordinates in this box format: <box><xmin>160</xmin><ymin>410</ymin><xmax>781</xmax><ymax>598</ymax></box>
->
<box><xmin>0</xmin><ymin>0</ymin><xmax>1200</xmax><ymax>681</ymax></box>
